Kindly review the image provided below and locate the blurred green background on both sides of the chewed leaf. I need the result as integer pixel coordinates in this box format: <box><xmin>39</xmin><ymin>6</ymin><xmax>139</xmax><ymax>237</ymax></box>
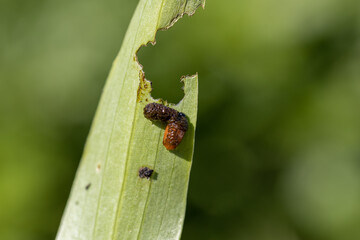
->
<box><xmin>0</xmin><ymin>0</ymin><xmax>360</xmax><ymax>240</ymax></box>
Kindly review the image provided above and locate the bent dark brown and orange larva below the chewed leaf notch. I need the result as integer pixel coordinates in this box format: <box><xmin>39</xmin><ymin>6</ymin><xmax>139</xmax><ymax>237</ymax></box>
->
<box><xmin>144</xmin><ymin>103</ymin><xmax>188</xmax><ymax>150</ymax></box>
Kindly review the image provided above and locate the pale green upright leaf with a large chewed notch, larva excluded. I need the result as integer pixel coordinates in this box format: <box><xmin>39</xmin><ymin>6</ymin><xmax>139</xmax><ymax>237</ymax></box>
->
<box><xmin>57</xmin><ymin>0</ymin><xmax>205</xmax><ymax>240</ymax></box>
